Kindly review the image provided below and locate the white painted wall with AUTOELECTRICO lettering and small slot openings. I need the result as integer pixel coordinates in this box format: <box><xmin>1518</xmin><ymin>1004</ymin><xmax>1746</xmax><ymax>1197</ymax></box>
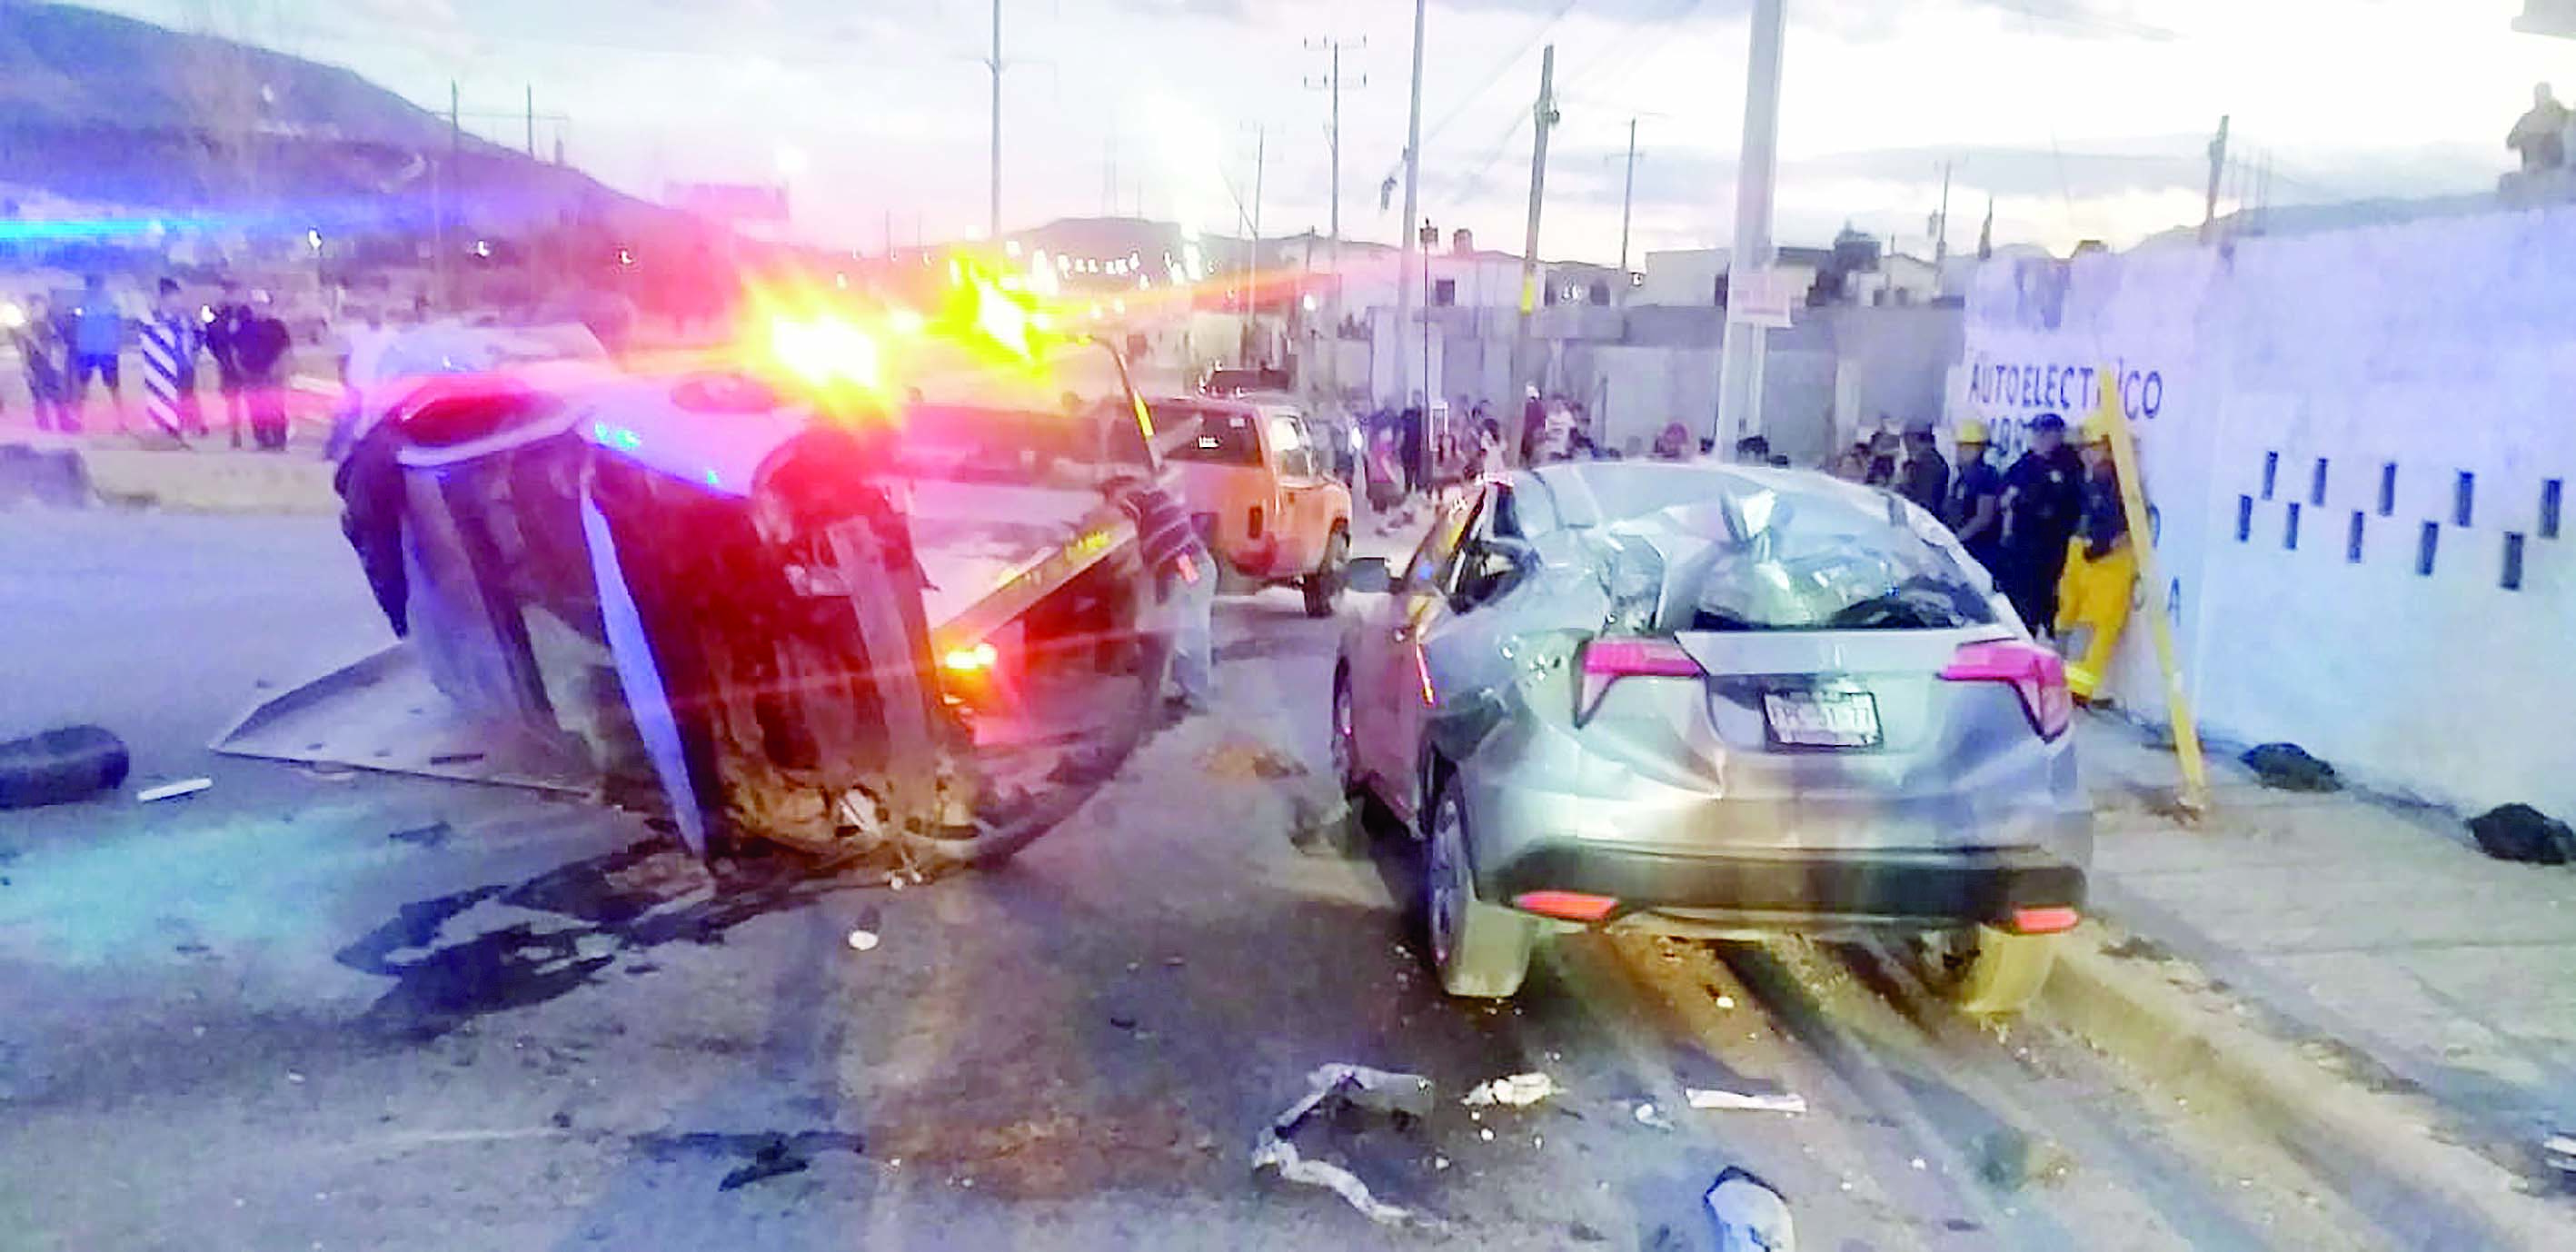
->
<box><xmin>1950</xmin><ymin>209</ymin><xmax>2576</xmax><ymax>817</ymax></box>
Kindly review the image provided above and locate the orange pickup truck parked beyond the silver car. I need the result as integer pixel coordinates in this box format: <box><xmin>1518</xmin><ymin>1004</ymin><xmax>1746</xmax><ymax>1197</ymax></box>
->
<box><xmin>1149</xmin><ymin>397</ymin><xmax>1350</xmax><ymax>618</ymax></box>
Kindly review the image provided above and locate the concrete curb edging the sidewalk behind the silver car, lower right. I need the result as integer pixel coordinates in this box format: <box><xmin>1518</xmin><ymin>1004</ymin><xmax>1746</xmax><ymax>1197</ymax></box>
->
<box><xmin>2037</xmin><ymin>925</ymin><xmax>2576</xmax><ymax>1249</ymax></box>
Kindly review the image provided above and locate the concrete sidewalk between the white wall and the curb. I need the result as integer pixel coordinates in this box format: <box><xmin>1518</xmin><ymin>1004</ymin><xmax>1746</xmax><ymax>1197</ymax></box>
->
<box><xmin>2076</xmin><ymin>713</ymin><xmax>2576</xmax><ymax>1167</ymax></box>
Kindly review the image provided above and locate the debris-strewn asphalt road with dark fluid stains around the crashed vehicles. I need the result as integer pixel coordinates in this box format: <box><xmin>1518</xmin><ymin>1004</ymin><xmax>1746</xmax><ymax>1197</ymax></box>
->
<box><xmin>0</xmin><ymin>512</ymin><xmax>2375</xmax><ymax>1249</ymax></box>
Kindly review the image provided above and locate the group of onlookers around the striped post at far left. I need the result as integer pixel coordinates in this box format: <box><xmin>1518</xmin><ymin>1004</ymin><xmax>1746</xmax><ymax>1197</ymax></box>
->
<box><xmin>0</xmin><ymin>273</ymin><xmax>293</xmax><ymax>451</ymax></box>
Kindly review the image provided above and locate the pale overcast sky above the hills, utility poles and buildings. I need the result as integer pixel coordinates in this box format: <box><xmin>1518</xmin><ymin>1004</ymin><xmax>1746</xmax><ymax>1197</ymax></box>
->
<box><xmin>101</xmin><ymin>0</ymin><xmax>2576</xmax><ymax>263</ymax></box>
